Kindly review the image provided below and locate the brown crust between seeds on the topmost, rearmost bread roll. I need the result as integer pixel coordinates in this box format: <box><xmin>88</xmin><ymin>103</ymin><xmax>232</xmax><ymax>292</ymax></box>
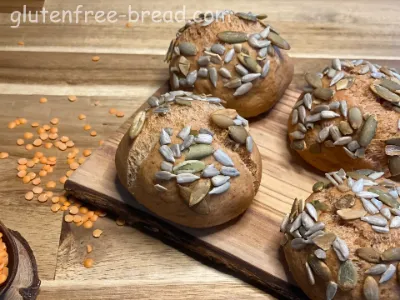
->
<box><xmin>166</xmin><ymin>15</ymin><xmax>294</xmax><ymax>118</ymax></box>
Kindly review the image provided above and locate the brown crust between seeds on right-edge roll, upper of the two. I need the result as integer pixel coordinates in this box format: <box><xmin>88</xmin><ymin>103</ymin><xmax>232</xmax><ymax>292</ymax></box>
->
<box><xmin>288</xmin><ymin>65</ymin><xmax>399</xmax><ymax>175</ymax></box>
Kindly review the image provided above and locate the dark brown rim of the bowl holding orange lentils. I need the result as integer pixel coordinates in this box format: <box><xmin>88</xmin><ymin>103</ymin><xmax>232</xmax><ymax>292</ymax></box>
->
<box><xmin>0</xmin><ymin>221</ymin><xmax>19</xmax><ymax>298</ymax></box>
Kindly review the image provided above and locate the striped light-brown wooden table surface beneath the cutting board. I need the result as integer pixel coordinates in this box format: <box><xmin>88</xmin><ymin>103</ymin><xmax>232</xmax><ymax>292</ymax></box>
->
<box><xmin>0</xmin><ymin>0</ymin><xmax>400</xmax><ymax>300</ymax></box>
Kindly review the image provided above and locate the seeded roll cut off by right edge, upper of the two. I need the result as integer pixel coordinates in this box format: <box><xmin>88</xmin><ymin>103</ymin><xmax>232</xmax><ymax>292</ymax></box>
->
<box><xmin>288</xmin><ymin>59</ymin><xmax>400</xmax><ymax>176</ymax></box>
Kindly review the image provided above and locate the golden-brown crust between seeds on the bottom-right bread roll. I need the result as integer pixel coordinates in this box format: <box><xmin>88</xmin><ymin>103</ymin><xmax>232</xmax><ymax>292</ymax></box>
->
<box><xmin>283</xmin><ymin>171</ymin><xmax>400</xmax><ymax>300</ymax></box>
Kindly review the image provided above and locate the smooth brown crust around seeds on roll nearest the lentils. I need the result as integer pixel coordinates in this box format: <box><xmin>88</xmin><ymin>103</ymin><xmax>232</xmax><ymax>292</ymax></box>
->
<box><xmin>116</xmin><ymin>101</ymin><xmax>261</xmax><ymax>228</ymax></box>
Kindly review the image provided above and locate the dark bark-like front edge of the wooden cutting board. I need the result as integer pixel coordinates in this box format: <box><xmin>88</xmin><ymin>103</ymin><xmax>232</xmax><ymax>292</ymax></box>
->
<box><xmin>65</xmin><ymin>181</ymin><xmax>307</xmax><ymax>300</ymax></box>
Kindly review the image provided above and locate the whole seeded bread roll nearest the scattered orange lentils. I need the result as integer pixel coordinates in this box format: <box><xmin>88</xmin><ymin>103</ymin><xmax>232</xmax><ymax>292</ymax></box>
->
<box><xmin>115</xmin><ymin>91</ymin><xmax>261</xmax><ymax>228</ymax></box>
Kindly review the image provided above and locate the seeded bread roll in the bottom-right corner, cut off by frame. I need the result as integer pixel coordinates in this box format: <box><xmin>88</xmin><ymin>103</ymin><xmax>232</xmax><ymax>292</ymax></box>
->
<box><xmin>281</xmin><ymin>169</ymin><xmax>400</xmax><ymax>300</ymax></box>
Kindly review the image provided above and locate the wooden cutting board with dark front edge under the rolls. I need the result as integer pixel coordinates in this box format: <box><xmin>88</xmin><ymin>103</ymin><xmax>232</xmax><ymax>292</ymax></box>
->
<box><xmin>65</xmin><ymin>84</ymin><xmax>319</xmax><ymax>299</ymax></box>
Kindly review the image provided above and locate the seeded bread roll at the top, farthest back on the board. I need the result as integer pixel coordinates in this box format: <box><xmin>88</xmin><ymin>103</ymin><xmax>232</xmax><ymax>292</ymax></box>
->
<box><xmin>166</xmin><ymin>11</ymin><xmax>293</xmax><ymax>118</ymax></box>
